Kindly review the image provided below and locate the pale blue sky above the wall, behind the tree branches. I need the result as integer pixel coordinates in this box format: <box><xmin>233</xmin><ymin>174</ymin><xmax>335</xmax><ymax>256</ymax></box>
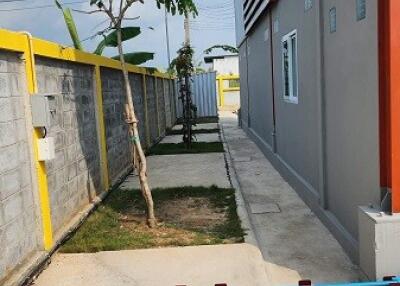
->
<box><xmin>0</xmin><ymin>0</ymin><xmax>235</xmax><ymax>69</ymax></box>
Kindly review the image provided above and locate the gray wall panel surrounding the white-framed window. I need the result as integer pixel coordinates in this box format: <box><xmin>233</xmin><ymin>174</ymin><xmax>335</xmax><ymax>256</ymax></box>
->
<box><xmin>272</xmin><ymin>0</ymin><xmax>319</xmax><ymax>193</ymax></box>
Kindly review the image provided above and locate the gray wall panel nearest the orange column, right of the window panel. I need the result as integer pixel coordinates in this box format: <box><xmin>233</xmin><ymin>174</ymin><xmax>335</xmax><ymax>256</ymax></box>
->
<box><xmin>323</xmin><ymin>0</ymin><xmax>380</xmax><ymax>237</ymax></box>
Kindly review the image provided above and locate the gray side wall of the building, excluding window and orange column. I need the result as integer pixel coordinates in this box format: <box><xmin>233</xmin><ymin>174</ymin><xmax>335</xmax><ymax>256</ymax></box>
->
<box><xmin>239</xmin><ymin>0</ymin><xmax>380</xmax><ymax>260</ymax></box>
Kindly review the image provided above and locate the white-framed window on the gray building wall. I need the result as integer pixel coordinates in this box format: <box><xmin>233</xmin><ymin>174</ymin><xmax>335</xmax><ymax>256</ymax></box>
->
<box><xmin>282</xmin><ymin>30</ymin><xmax>298</xmax><ymax>103</ymax></box>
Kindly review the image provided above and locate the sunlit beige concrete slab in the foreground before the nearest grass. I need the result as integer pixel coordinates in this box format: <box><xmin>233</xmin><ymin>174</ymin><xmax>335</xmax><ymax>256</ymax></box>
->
<box><xmin>35</xmin><ymin>244</ymin><xmax>268</xmax><ymax>286</ymax></box>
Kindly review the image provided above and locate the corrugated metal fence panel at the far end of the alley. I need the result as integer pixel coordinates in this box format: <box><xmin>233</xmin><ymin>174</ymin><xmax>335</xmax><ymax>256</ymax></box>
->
<box><xmin>175</xmin><ymin>72</ymin><xmax>218</xmax><ymax>118</ymax></box>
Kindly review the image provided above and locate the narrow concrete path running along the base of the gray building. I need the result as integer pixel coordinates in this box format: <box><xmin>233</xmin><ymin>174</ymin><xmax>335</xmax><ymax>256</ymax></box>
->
<box><xmin>220</xmin><ymin>112</ymin><xmax>360</xmax><ymax>285</ymax></box>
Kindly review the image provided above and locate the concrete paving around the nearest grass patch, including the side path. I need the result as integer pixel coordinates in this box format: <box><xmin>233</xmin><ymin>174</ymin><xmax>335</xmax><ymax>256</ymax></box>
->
<box><xmin>35</xmin><ymin>116</ymin><xmax>359</xmax><ymax>286</ymax></box>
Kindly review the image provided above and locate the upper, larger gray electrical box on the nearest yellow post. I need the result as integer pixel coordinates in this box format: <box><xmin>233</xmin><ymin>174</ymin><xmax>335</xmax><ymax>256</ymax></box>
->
<box><xmin>31</xmin><ymin>94</ymin><xmax>56</xmax><ymax>127</ymax></box>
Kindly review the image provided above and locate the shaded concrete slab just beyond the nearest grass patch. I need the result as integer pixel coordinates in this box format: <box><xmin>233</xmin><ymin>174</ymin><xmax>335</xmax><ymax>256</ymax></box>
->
<box><xmin>121</xmin><ymin>153</ymin><xmax>231</xmax><ymax>189</ymax></box>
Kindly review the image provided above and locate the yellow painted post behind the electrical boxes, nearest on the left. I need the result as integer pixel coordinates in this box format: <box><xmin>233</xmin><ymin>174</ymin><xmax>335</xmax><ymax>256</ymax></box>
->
<box><xmin>20</xmin><ymin>33</ymin><xmax>53</xmax><ymax>251</ymax></box>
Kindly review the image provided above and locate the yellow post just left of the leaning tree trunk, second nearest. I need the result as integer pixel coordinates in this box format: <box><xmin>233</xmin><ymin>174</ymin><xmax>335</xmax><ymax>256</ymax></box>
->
<box><xmin>94</xmin><ymin>65</ymin><xmax>110</xmax><ymax>191</ymax></box>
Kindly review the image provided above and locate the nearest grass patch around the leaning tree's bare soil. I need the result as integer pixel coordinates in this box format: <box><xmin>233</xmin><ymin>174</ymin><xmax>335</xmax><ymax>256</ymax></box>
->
<box><xmin>60</xmin><ymin>186</ymin><xmax>245</xmax><ymax>253</ymax></box>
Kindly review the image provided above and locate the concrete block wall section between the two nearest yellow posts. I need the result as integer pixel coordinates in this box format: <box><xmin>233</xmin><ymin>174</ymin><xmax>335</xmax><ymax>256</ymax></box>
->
<box><xmin>36</xmin><ymin>58</ymin><xmax>101</xmax><ymax>233</ymax></box>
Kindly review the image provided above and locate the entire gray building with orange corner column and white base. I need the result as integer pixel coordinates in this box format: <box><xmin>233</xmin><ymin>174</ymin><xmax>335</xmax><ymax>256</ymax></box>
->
<box><xmin>235</xmin><ymin>0</ymin><xmax>400</xmax><ymax>278</ymax></box>
